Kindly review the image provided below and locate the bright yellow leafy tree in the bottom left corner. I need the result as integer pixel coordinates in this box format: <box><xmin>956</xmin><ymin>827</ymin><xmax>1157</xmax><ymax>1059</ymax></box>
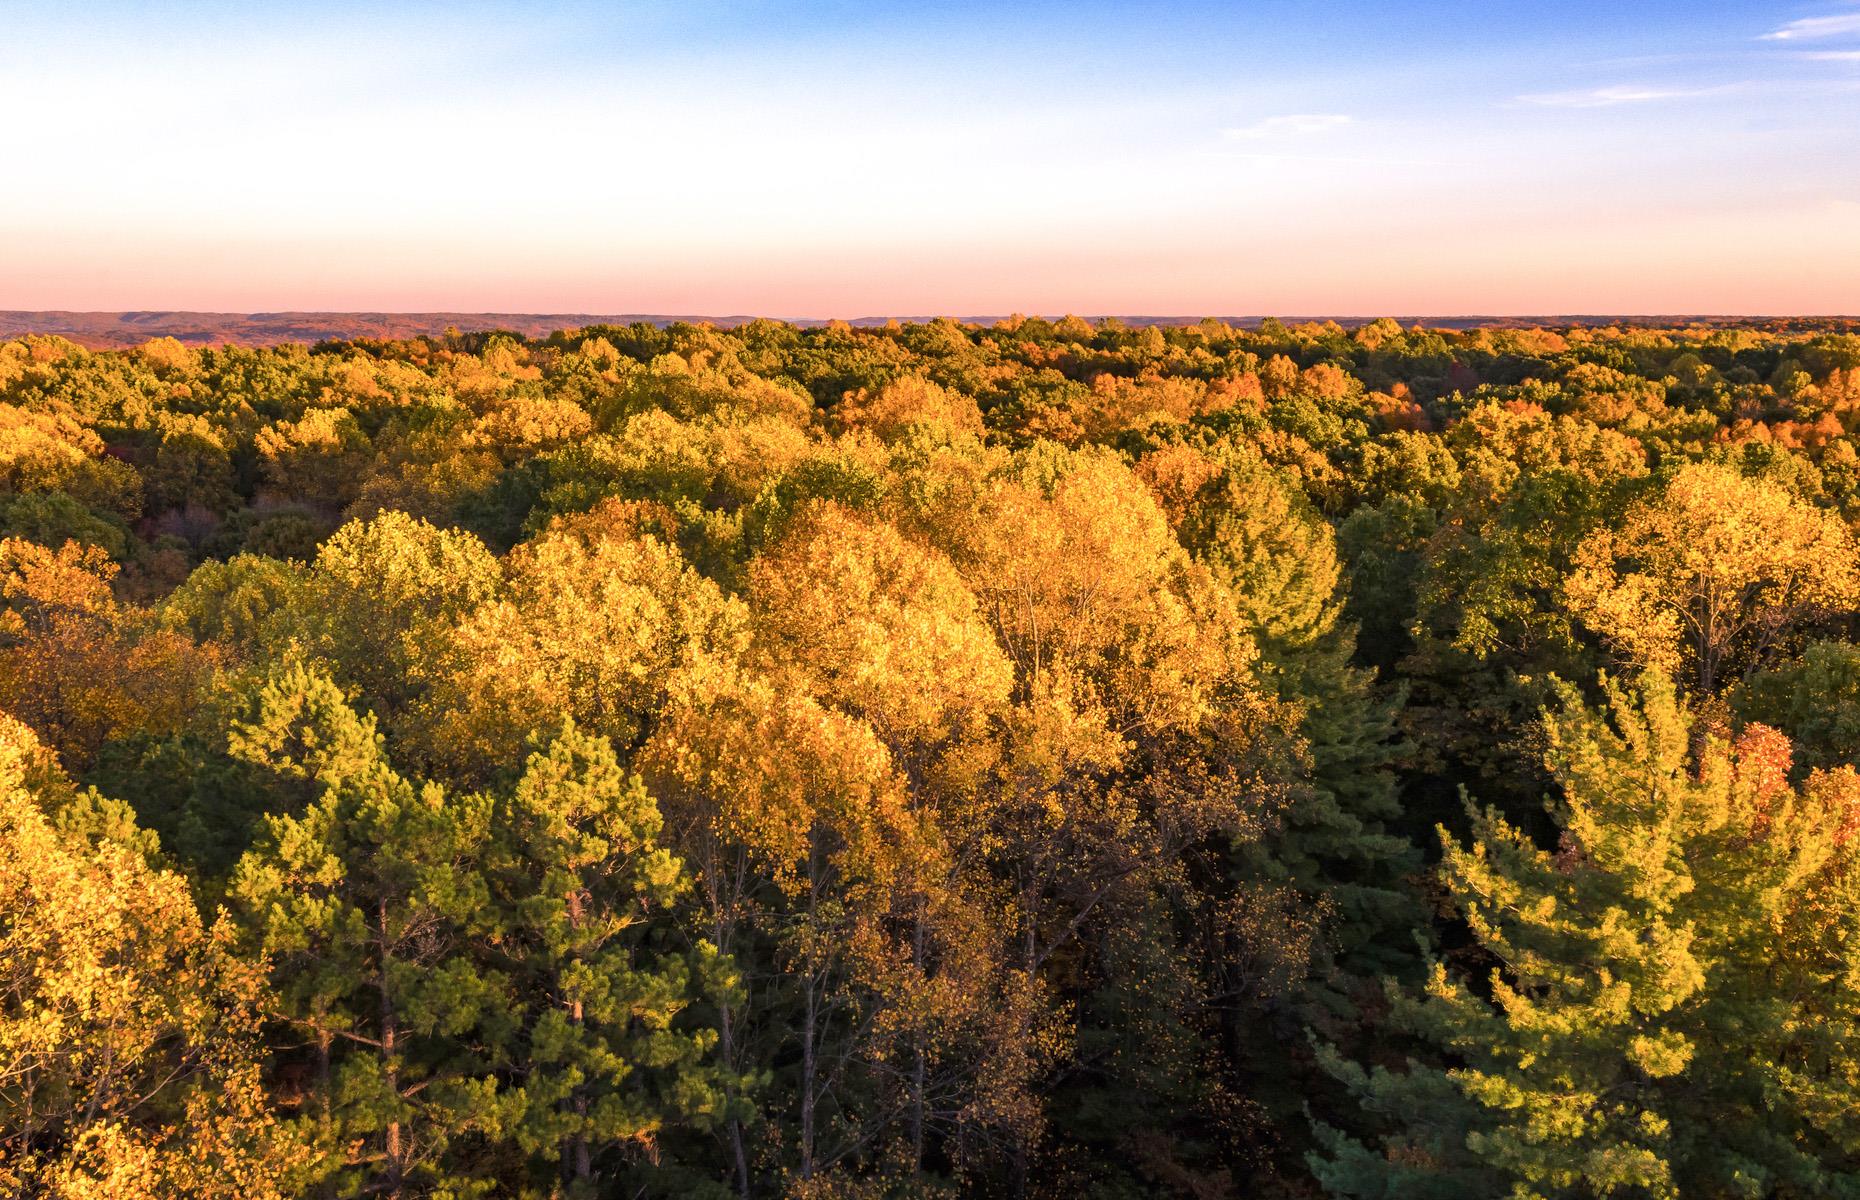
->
<box><xmin>0</xmin><ymin>718</ymin><xmax>309</xmax><ymax>1200</ymax></box>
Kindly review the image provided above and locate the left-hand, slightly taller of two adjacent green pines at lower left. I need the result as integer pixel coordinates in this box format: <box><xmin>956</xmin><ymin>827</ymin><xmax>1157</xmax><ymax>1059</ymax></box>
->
<box><xmin>231</xmin><ymin>668</ymin><xmax>513</xmax><ymax>1200</ymax></box>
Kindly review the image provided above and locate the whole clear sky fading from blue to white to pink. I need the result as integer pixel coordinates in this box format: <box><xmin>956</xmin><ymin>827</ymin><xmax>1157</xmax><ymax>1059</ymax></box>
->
<box><xmin>0</xmin><ymin>0</ymin><xmax>1860</xmax><ymax>318</ymax></box>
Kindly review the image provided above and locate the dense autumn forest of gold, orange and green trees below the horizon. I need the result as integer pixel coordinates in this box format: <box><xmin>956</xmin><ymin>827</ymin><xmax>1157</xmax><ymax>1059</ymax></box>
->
<box><xmin>0</xmin><ymin>318</ymin><xmax>1860</xmax><ymax>1200</ymax></box>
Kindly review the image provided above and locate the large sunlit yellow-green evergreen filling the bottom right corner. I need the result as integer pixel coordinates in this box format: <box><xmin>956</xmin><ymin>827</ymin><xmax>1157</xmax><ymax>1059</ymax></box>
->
<box><xmin>1311</xmin><ymin>675</ymin><xmax>1860</xmax><ymax>1200</ymax></box>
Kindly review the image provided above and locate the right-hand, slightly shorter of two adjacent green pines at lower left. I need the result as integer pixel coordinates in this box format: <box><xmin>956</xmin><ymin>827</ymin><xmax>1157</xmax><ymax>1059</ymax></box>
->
<box><xmin>487</xmin><ymin>724</ymin><xmax>750</xmax><ymax>1196</ymax></box>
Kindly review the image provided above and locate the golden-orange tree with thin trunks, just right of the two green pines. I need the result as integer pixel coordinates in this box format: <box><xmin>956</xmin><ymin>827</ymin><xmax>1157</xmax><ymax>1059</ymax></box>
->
<box><xmin>642</xmin><ymin>673</ymin><xmax>919</xmax><ymax>1181</ymax></box>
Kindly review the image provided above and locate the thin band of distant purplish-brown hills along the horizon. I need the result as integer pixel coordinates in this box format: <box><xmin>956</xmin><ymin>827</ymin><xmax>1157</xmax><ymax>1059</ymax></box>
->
<box><xmin>0</xmin><ymin>311</ymin><xmax>1860</xmax><ymax>350</ymax></box>
